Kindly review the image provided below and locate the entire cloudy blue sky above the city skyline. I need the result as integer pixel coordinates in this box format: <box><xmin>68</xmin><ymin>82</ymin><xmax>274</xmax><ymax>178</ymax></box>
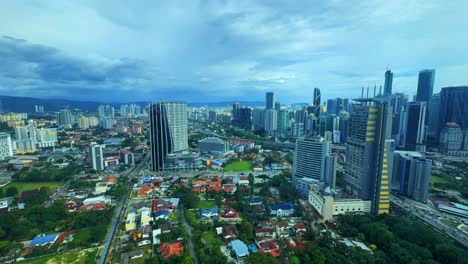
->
<box><xmin>0</xmin><ymin>0</ymin><xmax>468</xmax><ymax>103</ymax></box>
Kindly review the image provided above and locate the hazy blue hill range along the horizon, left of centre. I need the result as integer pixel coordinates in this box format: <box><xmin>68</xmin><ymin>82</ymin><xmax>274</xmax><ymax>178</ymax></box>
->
<box><xmin>0</xmin><ymin>95</ymin><xmax>265</xmax><ymax>113</ymax></box>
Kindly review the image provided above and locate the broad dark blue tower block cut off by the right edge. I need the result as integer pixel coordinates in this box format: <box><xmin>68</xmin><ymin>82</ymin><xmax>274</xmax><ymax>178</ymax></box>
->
<box><xmin>439</xmin><ymin>86</ymin><xmax>468</xmax><ymax>132</ymax></box>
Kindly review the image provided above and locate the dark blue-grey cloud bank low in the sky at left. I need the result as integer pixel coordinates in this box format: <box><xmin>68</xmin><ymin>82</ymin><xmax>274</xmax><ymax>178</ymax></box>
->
<box><xmin>0</xmin><ymin>36</ymin><xmax>152</xmax><ymax>86</ymax></box>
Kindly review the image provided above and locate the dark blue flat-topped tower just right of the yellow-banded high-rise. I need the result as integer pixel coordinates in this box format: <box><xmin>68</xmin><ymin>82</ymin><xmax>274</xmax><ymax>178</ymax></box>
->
<box><xmin>403</xmin><ymin>102</ymin><xmax>426</xmax><ymax>151</ymax></box>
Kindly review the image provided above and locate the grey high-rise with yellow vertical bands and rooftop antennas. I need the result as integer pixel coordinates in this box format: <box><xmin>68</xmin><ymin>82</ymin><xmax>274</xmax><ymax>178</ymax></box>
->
<box><xmin>345</xmin><ymin>98</ymin><xmax>395</xmax><ymax>214</ymax></box>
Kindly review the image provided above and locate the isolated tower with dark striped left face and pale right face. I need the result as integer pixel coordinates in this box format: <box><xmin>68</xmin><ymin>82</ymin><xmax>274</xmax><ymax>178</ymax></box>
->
<box><xmin>149</xmin><ymin>102</ymin><xmax>188</xmax><ymax>171</ymax></box>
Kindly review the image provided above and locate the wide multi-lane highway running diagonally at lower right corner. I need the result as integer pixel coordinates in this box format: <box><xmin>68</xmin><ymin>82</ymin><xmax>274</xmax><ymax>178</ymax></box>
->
<box><xmin>391</xmin><ymin>195</ymin><xmax>468</xmax><ymax>248</ymax></box>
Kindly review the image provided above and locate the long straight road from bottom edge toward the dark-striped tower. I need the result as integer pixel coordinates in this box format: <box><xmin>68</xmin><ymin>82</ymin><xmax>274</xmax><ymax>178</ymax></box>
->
<box><xmin>98</xmin><ymin>154</ymin><xmax>150</xmax><ymax>264</ymax></box>
